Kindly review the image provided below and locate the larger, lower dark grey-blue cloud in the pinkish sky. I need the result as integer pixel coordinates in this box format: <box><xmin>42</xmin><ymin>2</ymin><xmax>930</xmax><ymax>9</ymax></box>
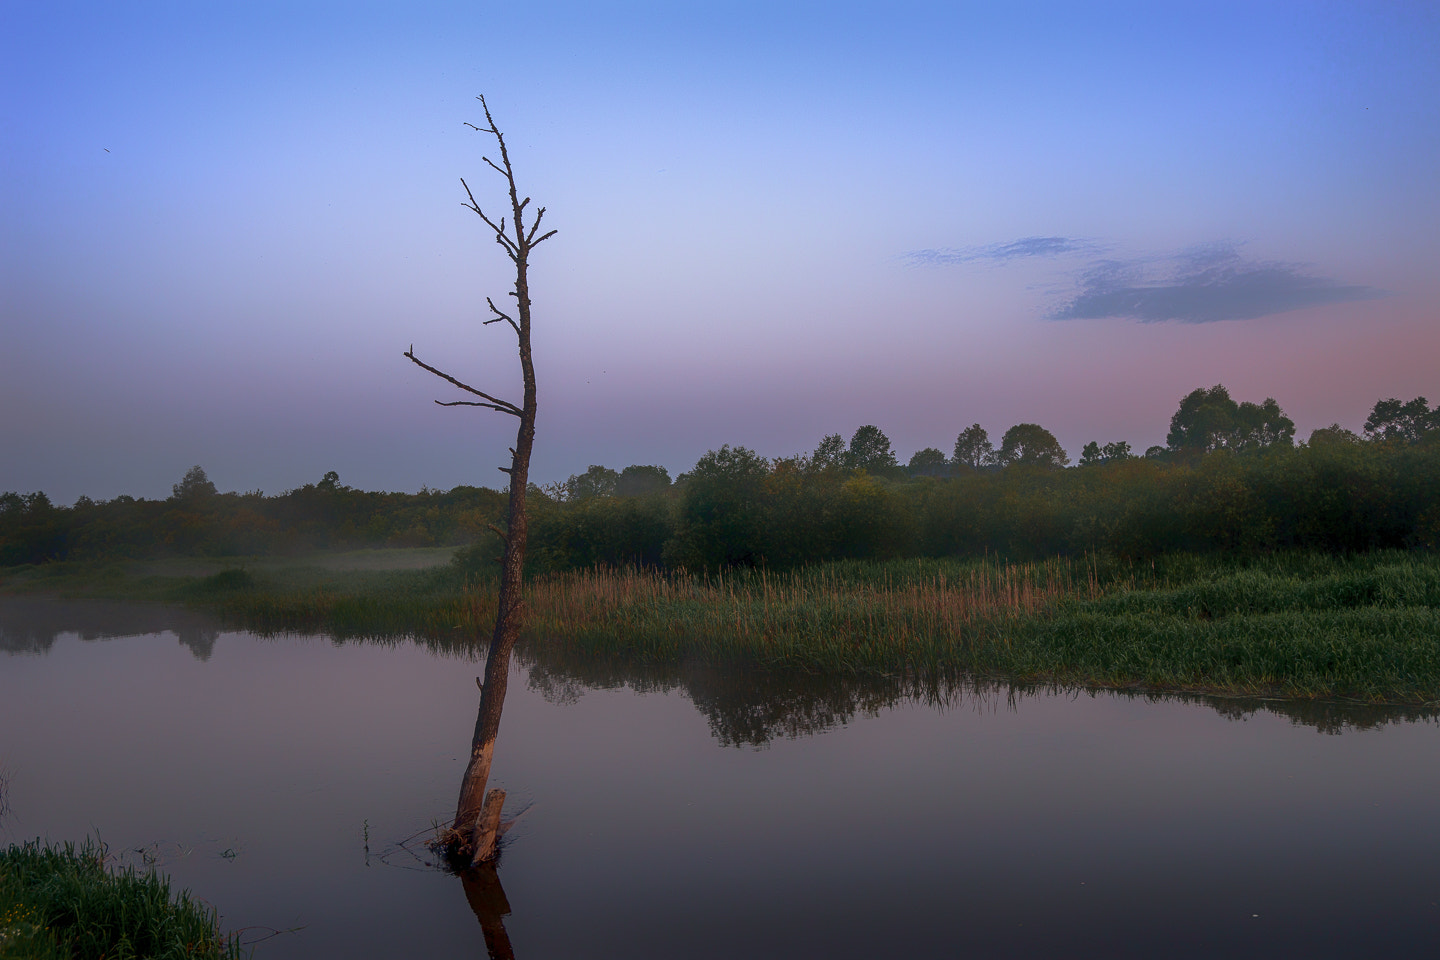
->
<box><xmin>1051</xmin><ymin>243</ymin><xmax>1387</xmax><ymax>324</ymax></box>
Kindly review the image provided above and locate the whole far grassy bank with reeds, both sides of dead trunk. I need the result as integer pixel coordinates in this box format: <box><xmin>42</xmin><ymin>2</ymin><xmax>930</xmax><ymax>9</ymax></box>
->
<box><xmin>2</xmin><ymin>551</ymin><xmax>1440</xmax><ymax>704</ymax></box>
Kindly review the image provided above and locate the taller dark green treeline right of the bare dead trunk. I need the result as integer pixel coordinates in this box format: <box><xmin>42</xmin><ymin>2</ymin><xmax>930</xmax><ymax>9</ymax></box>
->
<box><xmin>527</xmin><ymin>386</ymin><xmax>1440</xmax><ymax>570</ymax></box>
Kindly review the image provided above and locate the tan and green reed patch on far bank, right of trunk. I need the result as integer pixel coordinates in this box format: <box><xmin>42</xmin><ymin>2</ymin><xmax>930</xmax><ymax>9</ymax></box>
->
<box><xmin>518</xmin><ymin>561</ymin><xmax>1099</xmax><ymax>674</ymax></box>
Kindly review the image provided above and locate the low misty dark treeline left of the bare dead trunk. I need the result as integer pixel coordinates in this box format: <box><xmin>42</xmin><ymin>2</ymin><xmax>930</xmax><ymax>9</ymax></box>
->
<box><xmin>0</xmin><ymin>466</ymin><xmax>504</xmax><ymax>566</ymax></box>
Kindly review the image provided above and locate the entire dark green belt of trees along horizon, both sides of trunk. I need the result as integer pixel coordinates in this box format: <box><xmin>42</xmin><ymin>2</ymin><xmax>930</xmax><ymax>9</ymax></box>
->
<box><xmin>0</xmin><ymin>386</ymin><xmax>1440</xmax><ymax>571</ymax></box>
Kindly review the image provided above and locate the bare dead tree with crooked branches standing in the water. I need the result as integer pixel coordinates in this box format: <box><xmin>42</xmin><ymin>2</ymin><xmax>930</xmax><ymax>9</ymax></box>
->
<box><xmin>405</xmin><ymin>96</ymin><xmax>556</xmax><ymax>864</ymax></box>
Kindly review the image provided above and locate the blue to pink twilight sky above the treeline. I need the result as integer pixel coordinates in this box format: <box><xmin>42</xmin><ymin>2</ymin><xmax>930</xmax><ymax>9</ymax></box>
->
<box><xmin>0</xmin><ymin>0</ymin><xmax>1440</xmax><ymax>502</ymax></box>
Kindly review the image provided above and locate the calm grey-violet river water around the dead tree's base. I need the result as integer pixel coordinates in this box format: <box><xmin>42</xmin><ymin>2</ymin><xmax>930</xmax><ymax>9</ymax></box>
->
<box><xmin>0</xmin><ymin>599</ymin><xmax>1440</xmax><ymax>960</ymax></box>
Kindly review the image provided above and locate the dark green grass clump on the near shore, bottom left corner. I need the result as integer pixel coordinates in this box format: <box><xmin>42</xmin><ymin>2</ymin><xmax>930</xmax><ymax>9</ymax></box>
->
<box><xmin>0</xmin><ymin>841</ymin><xmax>242</xmax><ymax>960</ymax></box>
